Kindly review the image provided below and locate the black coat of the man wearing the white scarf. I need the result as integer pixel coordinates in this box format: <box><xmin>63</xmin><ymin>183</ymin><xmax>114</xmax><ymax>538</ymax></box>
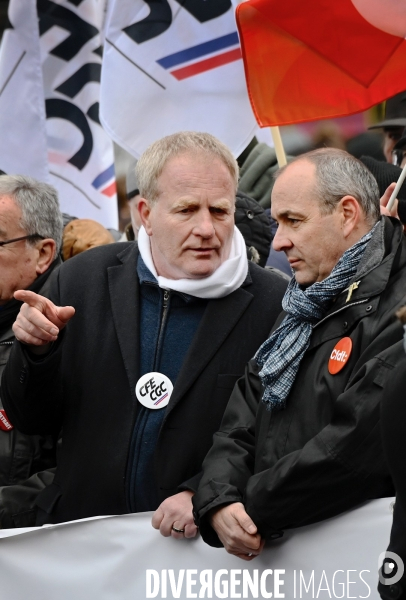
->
<box><xmin>2</xmin><ymin>243</ymin><xmax>286</xmax><ymax>522</ymax></box>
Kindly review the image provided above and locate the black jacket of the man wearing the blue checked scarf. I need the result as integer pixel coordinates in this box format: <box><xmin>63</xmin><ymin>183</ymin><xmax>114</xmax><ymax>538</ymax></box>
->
<box><xmin>193</xmin><ymin>218</ymin><xmax>406</xmax><ymax>546</ymax></box>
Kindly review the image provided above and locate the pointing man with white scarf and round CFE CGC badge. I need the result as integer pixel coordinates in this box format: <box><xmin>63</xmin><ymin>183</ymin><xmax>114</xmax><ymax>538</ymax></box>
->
<box><xmin>2</xmin><ymin>132</ymin><xmax>286</xmax><ymax>538</ymax></box>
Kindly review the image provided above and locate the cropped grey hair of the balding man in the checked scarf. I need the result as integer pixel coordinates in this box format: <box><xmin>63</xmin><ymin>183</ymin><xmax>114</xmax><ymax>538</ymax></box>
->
<box><xmin>275</xmin><ymin>148</ymin><xmax>381</xmax><ymax>227</ymax></box>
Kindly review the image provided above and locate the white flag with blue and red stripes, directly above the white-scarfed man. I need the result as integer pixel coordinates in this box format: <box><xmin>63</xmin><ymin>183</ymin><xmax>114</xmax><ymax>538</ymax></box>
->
<box><xmin>100</xmin><ymin>0</ymin><xmax>257</xmax><ymax>157</ymax></box>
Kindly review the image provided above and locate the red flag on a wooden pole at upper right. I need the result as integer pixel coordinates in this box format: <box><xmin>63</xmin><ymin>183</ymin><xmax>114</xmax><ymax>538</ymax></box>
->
<box><xmin>237</xmin><ymin>0</ymin><xmax>406</xmax><ymax>127</ymax></box>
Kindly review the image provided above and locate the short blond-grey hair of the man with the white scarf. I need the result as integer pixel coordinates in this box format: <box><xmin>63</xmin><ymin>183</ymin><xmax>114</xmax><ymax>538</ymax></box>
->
<box><xmin>135</xmin><ymin>131</ymin><xmax>238</xmax><ymax>202</ymax></box>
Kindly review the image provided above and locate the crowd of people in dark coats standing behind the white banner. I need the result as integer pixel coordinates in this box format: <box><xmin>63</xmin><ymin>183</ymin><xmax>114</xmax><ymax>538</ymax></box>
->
<box><xmin>0</xmin><ymin>94</ymin><xmax>406</xmax><ymax>598</ymax></box>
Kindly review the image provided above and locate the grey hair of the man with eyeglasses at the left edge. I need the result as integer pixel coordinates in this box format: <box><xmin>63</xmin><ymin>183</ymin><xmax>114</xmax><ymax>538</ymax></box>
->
<box><xmin>0</xmin><ymin>175</ymin><xmax>63</xmax><ymax>255</ymax></box>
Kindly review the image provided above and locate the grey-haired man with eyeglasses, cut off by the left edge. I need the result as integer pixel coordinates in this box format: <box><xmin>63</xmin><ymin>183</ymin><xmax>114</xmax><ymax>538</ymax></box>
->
<box><xmin>0</xmin><ymin>174</ymin><xmax>62</xmax><ymax>528</ymax></box>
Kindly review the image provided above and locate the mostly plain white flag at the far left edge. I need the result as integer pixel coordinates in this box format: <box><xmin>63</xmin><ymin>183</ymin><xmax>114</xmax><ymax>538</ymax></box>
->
<box><xmin>0</xmin><ymin>0</ymin><xmax>49</xmax><ymax>182</ymax></box>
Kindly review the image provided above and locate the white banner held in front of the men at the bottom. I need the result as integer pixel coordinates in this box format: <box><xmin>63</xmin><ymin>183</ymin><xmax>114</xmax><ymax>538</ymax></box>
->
<box><xmin>0</xmin><ymin>498</ymin><xmax>392</xmax><ymax>600</ymax></box>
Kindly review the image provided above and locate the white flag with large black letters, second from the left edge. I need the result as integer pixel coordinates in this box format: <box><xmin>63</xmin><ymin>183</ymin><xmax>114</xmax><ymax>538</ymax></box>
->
<box><xmin>37</xmin><ymin>0</ymin><xmax>117</xmax><ymax>228</ymax></box>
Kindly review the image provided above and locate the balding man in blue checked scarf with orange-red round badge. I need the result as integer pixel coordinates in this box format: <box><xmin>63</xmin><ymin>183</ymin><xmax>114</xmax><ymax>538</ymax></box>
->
<box><xmin>194</xmin><ymin>149</ymin><xmax>406</xmax><ymax>560</ymax></box>
